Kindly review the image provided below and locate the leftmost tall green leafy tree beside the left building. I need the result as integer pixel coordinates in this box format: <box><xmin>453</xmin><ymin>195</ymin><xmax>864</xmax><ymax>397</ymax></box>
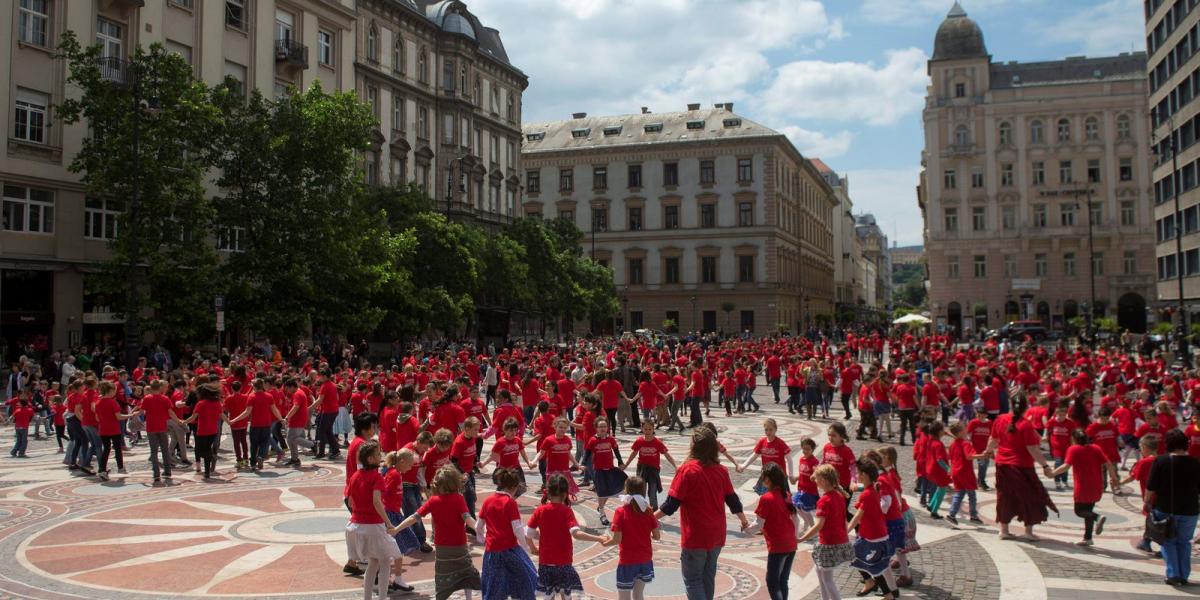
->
<box><xmin>56</xmin><ymin>31</ymin><xmax>221</xmax><ymax>349</ymax></box>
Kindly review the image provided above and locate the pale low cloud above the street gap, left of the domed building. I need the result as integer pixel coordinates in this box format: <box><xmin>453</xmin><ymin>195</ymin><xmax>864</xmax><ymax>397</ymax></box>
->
<box><xmin>846</xmin><ymin>167</ymin><xmax>925</xmax><ymax>246</ymax></box>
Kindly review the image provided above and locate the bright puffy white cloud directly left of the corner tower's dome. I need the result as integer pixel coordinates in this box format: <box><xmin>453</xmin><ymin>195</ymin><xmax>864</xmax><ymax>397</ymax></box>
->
<box><xmin>758</xmin><ymin>48</ymin><xmax>928</xmax><ymax>125</ymax></box>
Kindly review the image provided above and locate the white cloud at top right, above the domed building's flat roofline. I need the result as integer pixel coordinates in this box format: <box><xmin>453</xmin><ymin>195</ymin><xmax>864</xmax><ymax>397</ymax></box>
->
<box><xmin>1034</xmin><ymin>0</ymin><xmax>1146</xmax><ymax>56</ymax></box>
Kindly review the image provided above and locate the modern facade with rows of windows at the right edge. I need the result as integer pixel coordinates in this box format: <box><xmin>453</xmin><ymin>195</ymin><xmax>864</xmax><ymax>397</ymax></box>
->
<box><xmin>1144</xmin><ymin>0</ymin><xmax>1200</xmax><ymax>323</ymax></box>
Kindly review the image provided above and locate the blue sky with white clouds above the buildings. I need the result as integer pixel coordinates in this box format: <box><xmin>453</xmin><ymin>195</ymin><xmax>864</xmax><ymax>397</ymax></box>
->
<box><xmin>467</xmin><ymin>0</ymin><xmax>1145</xmax><ymax>246</ymax></box>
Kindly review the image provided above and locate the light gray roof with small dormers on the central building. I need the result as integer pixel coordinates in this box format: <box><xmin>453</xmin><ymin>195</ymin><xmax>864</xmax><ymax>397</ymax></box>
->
<box><xmin>521</xmin><ymin>108</ymin><xmax>782</xmax><ymax>152</ymax></box>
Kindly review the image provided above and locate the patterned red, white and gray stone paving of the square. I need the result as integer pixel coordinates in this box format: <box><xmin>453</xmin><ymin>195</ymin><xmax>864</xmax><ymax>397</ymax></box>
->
<box><xmin>0</xmin><ymin>376</ymin><xmax>1200</xmax><ymax>600</ymax></box>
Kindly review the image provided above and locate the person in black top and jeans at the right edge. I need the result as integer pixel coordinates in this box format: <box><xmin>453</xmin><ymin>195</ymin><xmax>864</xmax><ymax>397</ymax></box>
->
<box><xmin>1146</xmin><ymin>430</ymin><xmax>1200</xmax><ymax>586</ymax></box>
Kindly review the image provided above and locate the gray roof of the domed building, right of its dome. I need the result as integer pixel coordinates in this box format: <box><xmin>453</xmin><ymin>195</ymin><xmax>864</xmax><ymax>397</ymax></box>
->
<box><xmin>991</xmin><ymin>52</ymin><xmax>1146</xmax><ymax>90</ymax></box>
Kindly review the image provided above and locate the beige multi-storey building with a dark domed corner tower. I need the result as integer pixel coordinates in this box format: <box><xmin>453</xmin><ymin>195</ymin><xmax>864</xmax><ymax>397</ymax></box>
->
<box><xmin>918</xmin><ymin>4</ymin><xmax>1154</xmax><ymax>334</ymax></box>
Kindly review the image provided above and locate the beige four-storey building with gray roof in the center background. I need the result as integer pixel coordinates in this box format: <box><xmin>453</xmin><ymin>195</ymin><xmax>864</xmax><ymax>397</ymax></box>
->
<box><xmin>522</xmin><ymin>103</ymin><xmax>838</xmax><ymax>334</ymax></box>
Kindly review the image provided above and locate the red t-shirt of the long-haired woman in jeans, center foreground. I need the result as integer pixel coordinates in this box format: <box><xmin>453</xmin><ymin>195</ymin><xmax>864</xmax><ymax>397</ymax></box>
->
<box><xmin>667</xmin><ymin>461</ymin><xmax>733</xmax><ymax>550</ymax></box>
